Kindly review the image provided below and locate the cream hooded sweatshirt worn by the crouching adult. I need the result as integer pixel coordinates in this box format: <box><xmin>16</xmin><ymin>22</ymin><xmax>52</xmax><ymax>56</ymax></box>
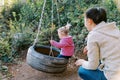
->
<box><xmin>82</xmin><ymin>22</ymin><xmax>120</xmax><ymax>80</ymax></box>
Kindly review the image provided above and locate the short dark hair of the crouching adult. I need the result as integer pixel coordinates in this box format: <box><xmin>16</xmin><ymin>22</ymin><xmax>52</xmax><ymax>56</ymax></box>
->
<box><xmin>85</xmin><ymin>8</ymin><xmax>107</xmax><ymax>24</ymax></box>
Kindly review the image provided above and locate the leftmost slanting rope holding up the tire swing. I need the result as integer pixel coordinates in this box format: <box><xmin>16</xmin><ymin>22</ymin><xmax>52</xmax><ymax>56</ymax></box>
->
<box><xmin>33</xmin><ymin>0</ymin><xmax>46</xmax><ymax>46</ymax></box>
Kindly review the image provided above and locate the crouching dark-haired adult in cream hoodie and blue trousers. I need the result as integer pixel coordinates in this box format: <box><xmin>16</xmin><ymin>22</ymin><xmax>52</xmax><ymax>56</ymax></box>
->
<box><xmin>75</xmin><ymin>8</ymin><xmax>120</xmax><ymax>80</ymax></box>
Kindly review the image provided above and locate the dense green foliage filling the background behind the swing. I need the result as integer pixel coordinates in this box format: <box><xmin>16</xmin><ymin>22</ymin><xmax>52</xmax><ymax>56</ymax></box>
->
<box><xmin>0</xmin><ymin>0</ymin><xmax>120</xmax><ymax>62</ymax></box>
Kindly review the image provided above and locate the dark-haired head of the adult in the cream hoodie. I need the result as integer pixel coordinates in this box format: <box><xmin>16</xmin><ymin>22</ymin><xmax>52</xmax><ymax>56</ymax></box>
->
<box><xmin>85</xmin><ymin>7</ymin><xmax>107</xmax><ymax>31</ymax></box>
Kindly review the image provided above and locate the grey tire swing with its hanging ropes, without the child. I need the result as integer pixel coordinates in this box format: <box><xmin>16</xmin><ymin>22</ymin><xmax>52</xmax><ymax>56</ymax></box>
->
<box><xmin>26</xmin><ymin>0</ymin><xmax>68</xmax><ymax>73</ymax></box>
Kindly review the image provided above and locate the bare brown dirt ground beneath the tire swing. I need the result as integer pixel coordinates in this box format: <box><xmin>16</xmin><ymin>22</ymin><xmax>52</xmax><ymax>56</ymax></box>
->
<box><xmin>3</xmin><ymin>50</ymin><xmax>86</xmax><ymax>80</ymax></box>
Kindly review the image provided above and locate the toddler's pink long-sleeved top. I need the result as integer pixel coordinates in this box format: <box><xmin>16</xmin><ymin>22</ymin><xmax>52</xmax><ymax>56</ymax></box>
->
<box><xmin>51</xmin><ymin>36</ymin><xmax>75</xmax><ymax>56</ymax></box>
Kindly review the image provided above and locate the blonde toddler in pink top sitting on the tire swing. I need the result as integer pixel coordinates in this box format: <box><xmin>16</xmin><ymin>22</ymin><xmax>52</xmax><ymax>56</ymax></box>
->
<box><xmin>50</xmin><ymin>24</ymin><xmax>74</xmax><ymax>59</ymax></box>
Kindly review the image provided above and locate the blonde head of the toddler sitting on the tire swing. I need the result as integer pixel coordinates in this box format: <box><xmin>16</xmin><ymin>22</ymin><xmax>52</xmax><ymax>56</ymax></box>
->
<box><xmin>58</xmin><ymin>24</ymin><xmax>71</xmax><ymax>38</ymax></box>
